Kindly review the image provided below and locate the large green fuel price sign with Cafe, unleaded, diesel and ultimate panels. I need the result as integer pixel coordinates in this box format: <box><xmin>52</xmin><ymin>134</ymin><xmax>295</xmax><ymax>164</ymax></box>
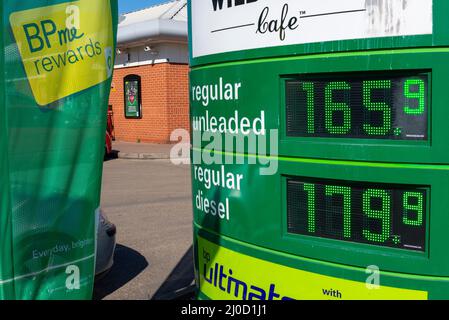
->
<box><xmin>189</xmin><ymin>0</ymin><xmax>449</xmax><ymax>300</ymax></box>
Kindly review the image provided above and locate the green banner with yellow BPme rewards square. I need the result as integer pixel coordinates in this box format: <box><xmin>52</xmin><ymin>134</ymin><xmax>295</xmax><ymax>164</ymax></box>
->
<box><xmin>0</xmin><ymin>0</ymin><xmax>117</xmax><ymax>299</ymax></box>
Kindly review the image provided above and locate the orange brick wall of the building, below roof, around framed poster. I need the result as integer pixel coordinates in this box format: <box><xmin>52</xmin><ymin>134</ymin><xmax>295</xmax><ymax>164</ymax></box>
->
<box><xmin>109</xmin><ymin>63</ymin><xmax>190</xmax><ymax>143</ymax></box>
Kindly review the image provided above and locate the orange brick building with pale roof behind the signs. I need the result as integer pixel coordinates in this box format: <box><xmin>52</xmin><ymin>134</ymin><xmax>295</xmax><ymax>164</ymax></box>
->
<box><xmin>109</xmin><ymin>0</ymin><xmax>189</xmax><ymax>143</ymax></box>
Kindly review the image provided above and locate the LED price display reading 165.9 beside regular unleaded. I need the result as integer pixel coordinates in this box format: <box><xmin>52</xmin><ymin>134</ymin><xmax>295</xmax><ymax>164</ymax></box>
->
<box><xmin>285</xmin><ymin>73</ymin><xmax>429</xmax><ymax>140</ymax></box>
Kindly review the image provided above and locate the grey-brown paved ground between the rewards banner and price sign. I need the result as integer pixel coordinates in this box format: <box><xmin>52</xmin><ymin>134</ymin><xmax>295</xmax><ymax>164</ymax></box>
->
<box><xmin>94</xmin><ymin>144</ymin><xmax>194</xmax><ymax>300</ymax></box>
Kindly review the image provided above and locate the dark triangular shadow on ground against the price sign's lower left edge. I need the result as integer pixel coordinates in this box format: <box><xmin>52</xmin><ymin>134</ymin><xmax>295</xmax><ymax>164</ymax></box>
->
<box><xmin>151</xmin><ymin>246</ymin><xmax>195</xmax><ymax>300</ymax></box>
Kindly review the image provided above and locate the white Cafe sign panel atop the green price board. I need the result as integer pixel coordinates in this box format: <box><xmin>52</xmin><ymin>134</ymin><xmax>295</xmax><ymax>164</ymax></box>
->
<box><xmin>191</xmin><ymin>0</ymin><xmax>433</xmax><ymax>58</ymax></box>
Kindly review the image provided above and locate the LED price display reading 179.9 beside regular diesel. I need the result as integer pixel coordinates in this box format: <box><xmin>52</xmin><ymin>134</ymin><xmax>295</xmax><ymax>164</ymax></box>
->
<box><xmin>287</xmin><ymin>179</ymin><xmax>427</xmax><ymax>251</ymax></box>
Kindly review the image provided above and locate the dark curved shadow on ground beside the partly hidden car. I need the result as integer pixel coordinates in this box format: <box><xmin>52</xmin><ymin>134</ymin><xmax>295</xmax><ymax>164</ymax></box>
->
<box><xmin>93</xmin><ymin>244</ymin><xmax>148</xmax><ymax>300</ymax></box>
